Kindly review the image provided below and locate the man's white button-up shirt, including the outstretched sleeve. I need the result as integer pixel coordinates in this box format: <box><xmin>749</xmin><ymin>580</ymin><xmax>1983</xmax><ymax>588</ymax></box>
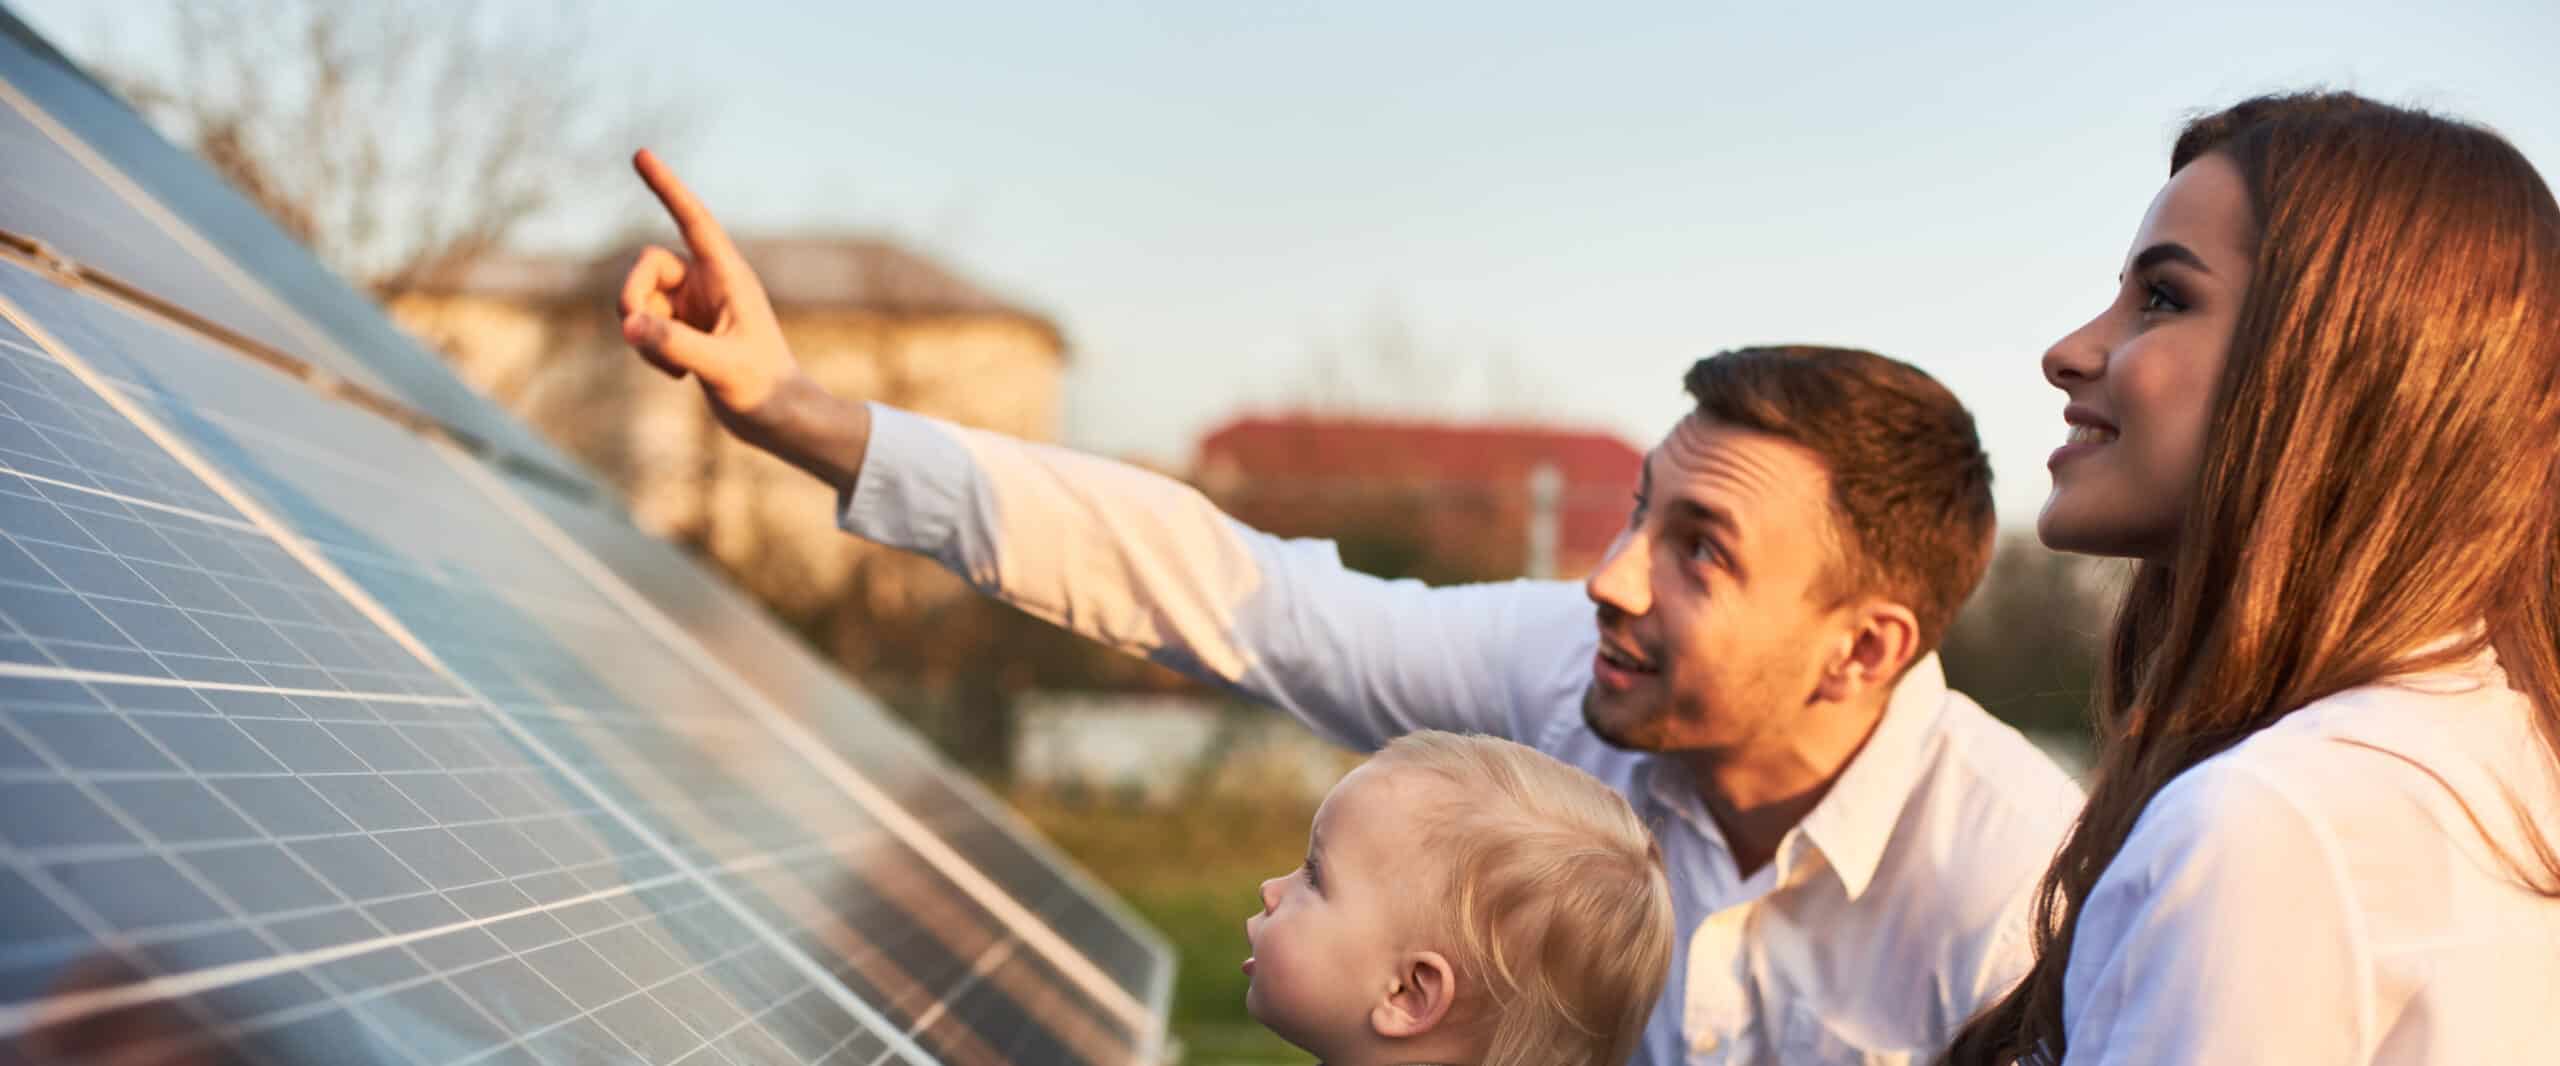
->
<box><xmin>840</xmin><ymin>405</ymin><xmax>2081</xmax><ymax>1066</ymax></box>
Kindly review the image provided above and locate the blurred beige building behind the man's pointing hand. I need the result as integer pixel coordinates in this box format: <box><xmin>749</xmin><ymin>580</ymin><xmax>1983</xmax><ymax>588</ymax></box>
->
<box><xmin>392</xmin><ymin>236</ymin><xmax>1065</xmax><ymax>666</ymax></box>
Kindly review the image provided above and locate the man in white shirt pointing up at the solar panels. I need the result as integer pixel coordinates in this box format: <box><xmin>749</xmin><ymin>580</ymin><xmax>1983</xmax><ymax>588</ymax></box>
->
<box><xmin>622</xmin><ymin>151</ymin><xmax>2081</xmax><ymax>1066</ymax></box>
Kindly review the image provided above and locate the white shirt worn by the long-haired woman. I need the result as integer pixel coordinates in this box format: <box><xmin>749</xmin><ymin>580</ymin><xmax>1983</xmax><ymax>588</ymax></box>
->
<box><xmin>2063</xmin><ymin>656</ymin><xmax>2560</xmax><ymax>1066</ymax></box>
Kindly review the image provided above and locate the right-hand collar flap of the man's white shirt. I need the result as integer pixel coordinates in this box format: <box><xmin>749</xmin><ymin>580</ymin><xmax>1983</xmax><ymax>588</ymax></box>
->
<box><xmin>1797</xmin><ymin>653</ymin><xmax>1946</xmax><ymax>899</ymax></box>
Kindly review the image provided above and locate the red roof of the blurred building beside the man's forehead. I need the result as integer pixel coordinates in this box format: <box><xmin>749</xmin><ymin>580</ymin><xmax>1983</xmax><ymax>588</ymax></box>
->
<box><xmin>1196</xmin><ymin>415</ymin><xmax>1644</xmax><ymax>571</ymax></box>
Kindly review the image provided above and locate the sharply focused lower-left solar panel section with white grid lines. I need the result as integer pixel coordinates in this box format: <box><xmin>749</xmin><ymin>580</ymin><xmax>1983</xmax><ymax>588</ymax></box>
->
<box><xmin>0</xmin><ymin>285</ymin><xmax>921</xmax><ymax>1063</ymax></box>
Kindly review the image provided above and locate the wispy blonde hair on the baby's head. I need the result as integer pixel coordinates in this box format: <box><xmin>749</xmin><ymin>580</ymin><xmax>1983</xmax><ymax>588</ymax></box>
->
<box><xmin>1375</xmin><ymin>730</ymin><xmax>1672</xmax><ymax>1066</ymax></box>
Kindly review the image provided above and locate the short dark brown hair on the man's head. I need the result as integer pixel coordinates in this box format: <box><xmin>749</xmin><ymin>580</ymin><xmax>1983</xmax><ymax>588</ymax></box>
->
<box><xmin>1682</xmin><ymin>343</ymin><xmax>1997</xmax><ymax>661</ymax></box>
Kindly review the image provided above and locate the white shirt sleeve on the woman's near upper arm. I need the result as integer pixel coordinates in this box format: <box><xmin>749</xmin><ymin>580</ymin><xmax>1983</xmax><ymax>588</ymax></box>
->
<box><xmin>2063</xmin><ymin>761</ymin><xmax>2373</xmax><ymax>1066</ymax></box>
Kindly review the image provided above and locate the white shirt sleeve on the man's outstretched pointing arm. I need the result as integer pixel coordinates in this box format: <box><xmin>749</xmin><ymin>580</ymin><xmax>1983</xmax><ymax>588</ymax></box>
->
<box><xmin>837</xmin><ymin>405</ymin><xmax>1592</xmax><ymax>751</ymax></box>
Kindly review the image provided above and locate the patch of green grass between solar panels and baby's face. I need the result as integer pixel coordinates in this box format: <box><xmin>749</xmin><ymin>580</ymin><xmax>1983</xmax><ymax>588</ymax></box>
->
<box><xmin>1011</xmin><ymin>782</ymin><xmax>1316</xmax><ymax>1066</ymax></box>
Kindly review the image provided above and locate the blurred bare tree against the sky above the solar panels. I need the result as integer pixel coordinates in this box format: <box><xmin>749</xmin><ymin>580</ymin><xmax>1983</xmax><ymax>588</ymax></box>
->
<box><xmin>100</xmin><ymin>0</ymin><xmax>686</xmax><ymax>300</ymax></box>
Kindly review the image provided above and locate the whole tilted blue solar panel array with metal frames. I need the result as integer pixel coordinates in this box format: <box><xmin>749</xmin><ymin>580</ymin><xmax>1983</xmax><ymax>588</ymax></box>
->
<box><xmin>0</xmin><ymin>13</ymin><xmax>1170</xmax><ymax>1066</ymax></box>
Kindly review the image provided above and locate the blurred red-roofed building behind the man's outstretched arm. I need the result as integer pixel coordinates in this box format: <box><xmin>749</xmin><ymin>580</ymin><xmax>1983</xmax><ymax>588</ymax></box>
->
<box><xmin>1193</xmin><ymin>415</ymin><xmax>1644</xmax><ymax>582</ymax></box>
